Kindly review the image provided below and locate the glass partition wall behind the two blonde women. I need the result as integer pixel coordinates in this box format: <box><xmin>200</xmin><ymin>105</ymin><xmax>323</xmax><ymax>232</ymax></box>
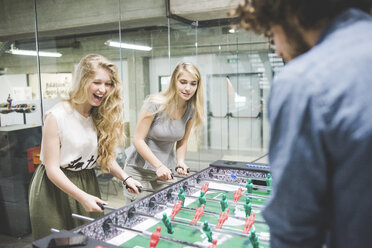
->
<box><xmin>0</xmin><ymin>0</ymin><xmax>283</xmax><ymax>179</ymax></box>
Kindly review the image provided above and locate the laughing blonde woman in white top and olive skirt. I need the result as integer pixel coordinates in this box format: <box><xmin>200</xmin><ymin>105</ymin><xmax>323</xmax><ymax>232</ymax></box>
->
<box><xmin>29</xmin><ymin>54</ymin><xmax>141</xmax><ymax>239</ymax></box>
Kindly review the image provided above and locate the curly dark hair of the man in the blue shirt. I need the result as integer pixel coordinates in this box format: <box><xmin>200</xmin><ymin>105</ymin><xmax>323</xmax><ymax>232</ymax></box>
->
<box><xmin>231</xmin><ymin>0</ymin><xmax>372</xmax><ymax>34</ymax></box>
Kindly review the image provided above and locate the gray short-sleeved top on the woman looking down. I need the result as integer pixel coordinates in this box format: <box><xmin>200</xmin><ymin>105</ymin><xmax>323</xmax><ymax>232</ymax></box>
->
<box><xmin>125</xmin><ymin>103</ymin><xmax>194</xmax><ymax>170</ymax></box>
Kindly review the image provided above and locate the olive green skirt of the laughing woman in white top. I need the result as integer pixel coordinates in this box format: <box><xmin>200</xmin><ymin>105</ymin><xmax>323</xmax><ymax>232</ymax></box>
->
<box><xmin>29</xmin><ymin>165</ymin><xmax>102</xmax><ymax>240</ymax></box>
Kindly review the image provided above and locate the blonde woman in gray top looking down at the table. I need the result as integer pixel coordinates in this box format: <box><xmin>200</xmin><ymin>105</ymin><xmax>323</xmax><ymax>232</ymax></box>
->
<box><xmin>124</xmin><ymin>62</ymin><xmax>204</xmax><ymax>200</ymax></box>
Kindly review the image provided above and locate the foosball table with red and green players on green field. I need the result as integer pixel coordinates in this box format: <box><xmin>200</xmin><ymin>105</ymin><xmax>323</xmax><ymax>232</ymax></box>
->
<box><xmin>33</xmin><ymin>160</ymin><xmax>271</xmax><ymax>248</ymax></box>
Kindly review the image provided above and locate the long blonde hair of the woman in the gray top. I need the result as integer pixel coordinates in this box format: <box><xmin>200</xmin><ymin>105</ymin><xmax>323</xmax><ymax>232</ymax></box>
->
<box><xmin>145</xmin><ymin>62</ymin><xmax>204</xmax><ymax>131</ymax></box>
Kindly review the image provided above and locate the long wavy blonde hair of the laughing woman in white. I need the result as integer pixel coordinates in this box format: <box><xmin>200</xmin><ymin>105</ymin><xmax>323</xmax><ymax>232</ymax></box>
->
<box><xmin>67</xmin><ymin>54</ymin><xmax>125</xmax><ymax>172</ymax></box>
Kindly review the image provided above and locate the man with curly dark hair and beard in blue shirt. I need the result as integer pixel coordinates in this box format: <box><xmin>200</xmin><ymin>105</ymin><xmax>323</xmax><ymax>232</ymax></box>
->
<box><xmin>235</xmin><ymin>0</ymin><xmax>372</xmax><ymax>248</ymax></box>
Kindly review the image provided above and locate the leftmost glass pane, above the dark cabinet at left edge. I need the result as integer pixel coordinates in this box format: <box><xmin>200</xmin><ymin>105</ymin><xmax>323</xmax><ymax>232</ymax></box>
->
<box><xmin>0</xmin><ymin>1</ymin><xmax>41</xmax><ymax>126</ymax></box>
